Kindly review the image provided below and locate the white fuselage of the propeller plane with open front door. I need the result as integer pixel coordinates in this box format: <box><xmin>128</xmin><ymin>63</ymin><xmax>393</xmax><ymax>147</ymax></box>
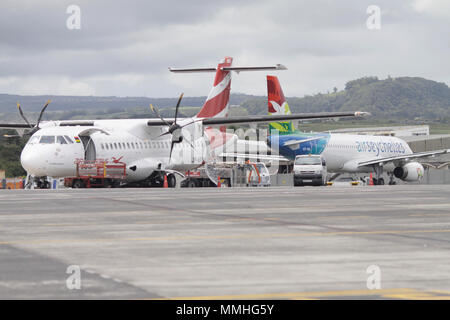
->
<box><xmin>21</xmin><ymin>119</ymin><xmax>236</xmax><ymax>182</ymax></box>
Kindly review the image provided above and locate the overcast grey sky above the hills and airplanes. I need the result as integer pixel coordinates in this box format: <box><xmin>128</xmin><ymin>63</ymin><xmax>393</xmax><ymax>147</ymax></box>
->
<box><xmin>0</xmin><ymin>0</ymin><xmax>450</xmax><ymax>97</ymax></box>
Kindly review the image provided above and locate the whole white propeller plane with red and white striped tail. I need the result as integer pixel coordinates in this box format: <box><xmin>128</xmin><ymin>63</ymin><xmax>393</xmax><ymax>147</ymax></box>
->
<box><xmin>0</xmin><ymin>57</ymin><xmax>362</xmax><ymax>187</ymax></box>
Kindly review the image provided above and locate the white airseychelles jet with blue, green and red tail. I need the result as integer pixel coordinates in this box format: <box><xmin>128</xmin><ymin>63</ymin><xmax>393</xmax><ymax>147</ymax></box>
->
<box><xmin>267</xmin><ymin>76</ymin><xmax>450</xmax><ymax>185</ymax></box>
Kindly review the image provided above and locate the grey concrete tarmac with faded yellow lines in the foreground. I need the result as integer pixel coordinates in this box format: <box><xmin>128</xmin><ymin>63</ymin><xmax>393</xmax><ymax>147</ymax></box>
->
<box><xmin>0</xmin><ymin>185</ymin><xmax>450</xmax><ymax>299</ymax></box>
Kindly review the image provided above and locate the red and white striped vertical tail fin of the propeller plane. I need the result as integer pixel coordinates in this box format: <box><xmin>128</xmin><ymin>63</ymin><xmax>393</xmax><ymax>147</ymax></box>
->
<box><xmin>197</xmin><ymin>57</ymin><xmax>233</xmax><ymax>118</ymax></box>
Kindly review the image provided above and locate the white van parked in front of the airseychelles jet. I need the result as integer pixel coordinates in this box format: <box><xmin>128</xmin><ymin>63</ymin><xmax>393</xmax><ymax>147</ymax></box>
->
<box><xmin>293</xmin><ymin>155</ymin><xmax>327</xmax><ymax>186</ymax></box>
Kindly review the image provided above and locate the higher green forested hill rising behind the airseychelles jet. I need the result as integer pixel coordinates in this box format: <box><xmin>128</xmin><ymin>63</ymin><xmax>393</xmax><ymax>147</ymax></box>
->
<box><xmin>242</xmin><ymin>77</ymin><xmax>450</xmax><ymax>121</ymax></box>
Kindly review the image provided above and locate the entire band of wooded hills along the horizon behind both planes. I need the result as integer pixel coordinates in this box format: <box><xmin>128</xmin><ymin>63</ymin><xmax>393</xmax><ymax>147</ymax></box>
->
<box><xmin>0</xmin><ymin>77</ymin><xmax>450</xmax><ymax>122</ymax></box>
